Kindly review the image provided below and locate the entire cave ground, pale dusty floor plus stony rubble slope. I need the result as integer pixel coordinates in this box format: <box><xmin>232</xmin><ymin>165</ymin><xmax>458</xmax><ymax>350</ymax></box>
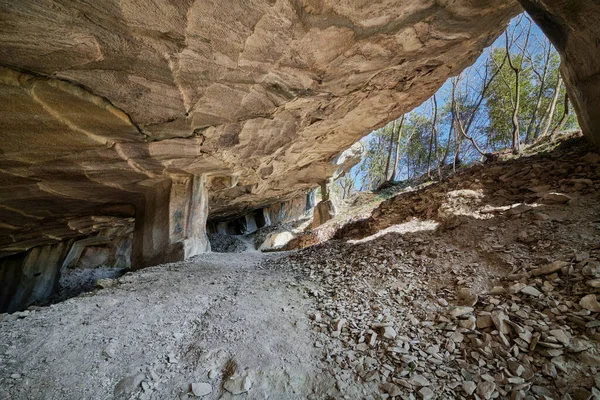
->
<box><xmin>0</xmin><ymin>135</ymin><xmax>600</xmax><ymax>400</ymax></box>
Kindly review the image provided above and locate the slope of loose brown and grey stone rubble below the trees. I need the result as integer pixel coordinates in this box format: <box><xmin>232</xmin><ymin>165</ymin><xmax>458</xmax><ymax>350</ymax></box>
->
<box><xmin>264</xmin><ymin>134</ymin><xmax>600</xmax><ymax>400</ymax></box>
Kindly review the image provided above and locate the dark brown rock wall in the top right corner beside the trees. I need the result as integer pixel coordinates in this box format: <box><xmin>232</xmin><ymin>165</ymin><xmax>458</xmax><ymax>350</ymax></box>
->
<box><xmin>519</xmin><ymin>0</ymin><xmax>600</xmax><ymax>147</ymax></box>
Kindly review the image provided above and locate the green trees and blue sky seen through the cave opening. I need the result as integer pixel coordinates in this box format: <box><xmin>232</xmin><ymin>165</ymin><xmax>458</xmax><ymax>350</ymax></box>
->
<box><xmin>334</xmin><ymin>17</ymin><xmax>578</xmax><ymax>196</ymax></box>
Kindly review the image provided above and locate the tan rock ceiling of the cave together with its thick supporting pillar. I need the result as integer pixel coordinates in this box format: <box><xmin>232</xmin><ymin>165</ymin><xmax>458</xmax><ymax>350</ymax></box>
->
<box><xmin>0</xmin><ymin>0</ymin><xmax>521</xmax><ymax>310</ymax></box>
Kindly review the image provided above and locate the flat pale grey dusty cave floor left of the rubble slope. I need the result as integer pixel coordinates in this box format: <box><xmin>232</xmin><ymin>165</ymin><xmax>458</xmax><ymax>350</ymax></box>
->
<box><xmin>0</xmin><ymin>252</ymin><xmax>326</xmax><ymax>399</ymax></box>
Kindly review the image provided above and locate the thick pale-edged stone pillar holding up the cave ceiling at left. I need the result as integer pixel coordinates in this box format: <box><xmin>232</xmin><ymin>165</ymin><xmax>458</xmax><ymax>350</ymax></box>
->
<box><xmin>132</xmin><ymin>175</ymin><xmax>210</xmax><ymax>269</ymax></box>
